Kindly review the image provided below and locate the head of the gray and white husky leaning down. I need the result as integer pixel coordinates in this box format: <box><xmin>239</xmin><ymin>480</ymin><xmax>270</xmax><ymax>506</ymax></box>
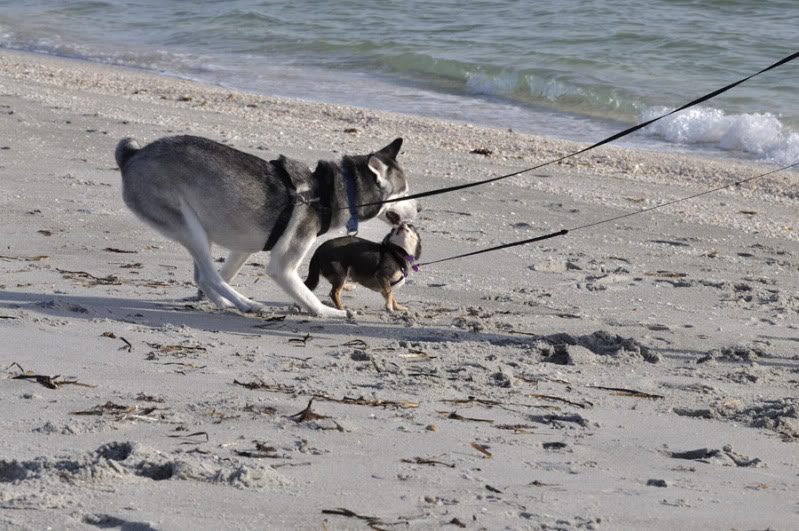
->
<box><xmin>368</xmin><ymin>138</ymin><xmax>421</xmax><ymax>225</ymax></box>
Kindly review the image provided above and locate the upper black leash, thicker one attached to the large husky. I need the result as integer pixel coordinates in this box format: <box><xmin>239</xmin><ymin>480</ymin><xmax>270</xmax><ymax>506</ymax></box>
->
<box><xmin>352</xmin><ymin>48</ymin><xmax>799</xmax><ymax>208</ymax></box>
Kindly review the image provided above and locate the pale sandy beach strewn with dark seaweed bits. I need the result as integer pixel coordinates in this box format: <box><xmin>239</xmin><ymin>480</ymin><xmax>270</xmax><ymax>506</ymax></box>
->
<box><xmin>0</xmin><ymin>47</ymin><xmax>799</xmax><ymax>531</ymax></box>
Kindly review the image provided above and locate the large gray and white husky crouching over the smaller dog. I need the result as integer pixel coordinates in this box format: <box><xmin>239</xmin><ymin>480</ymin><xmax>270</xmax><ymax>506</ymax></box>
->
<box><xmin>116</xmin><ymin>136</ymin><xmax>418</xmax><ymax>317</ymax></box>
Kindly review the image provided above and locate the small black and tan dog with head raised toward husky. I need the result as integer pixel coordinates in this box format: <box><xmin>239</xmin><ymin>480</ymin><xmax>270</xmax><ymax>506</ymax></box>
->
<box><xmin>305</xmin><ymin>223</ymin><xmax>422</xmax><ymax>312</ymax></box>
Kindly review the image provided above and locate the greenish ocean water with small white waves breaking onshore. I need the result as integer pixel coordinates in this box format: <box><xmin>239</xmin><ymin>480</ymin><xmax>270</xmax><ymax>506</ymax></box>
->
<box><xmin>0</xmin><ymin>0</ymin><xmax>799</xmax><ymax>164</ymax></box>
